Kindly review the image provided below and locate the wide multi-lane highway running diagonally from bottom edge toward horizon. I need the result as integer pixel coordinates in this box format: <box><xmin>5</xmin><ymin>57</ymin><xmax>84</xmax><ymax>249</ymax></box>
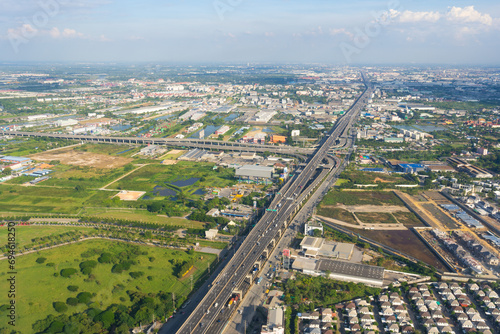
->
<box><xmin>172</xmin><ymin>73</ymin><xmax>372</xmax><ymax>334</ymax></box>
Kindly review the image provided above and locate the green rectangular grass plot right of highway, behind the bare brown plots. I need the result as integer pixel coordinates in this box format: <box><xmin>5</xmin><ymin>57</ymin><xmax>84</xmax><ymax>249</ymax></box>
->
<box><xmin>322</xmin><ymin>190</ymin><xmax>404</xmax><ymax>205</ymax></box>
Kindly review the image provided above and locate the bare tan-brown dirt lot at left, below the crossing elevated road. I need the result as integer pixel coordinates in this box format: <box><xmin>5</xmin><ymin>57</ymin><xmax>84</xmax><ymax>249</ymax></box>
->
<box><xmin>30</xmin><ymin>148</ymin><xmax>132</xmax><ymax>168</ymax></box>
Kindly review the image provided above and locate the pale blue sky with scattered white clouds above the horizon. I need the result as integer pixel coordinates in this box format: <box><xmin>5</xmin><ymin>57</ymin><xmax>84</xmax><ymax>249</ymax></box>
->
<box><xmin>0</xmin><ymin>0</ymin><xmax>500</xmax><ymax>65</ymax></box>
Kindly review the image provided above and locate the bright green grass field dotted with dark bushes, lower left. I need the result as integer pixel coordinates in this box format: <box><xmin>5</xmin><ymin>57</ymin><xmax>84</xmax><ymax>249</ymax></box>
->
<box><xmin>0</xmin><ymin>240</ymin><xmax>216</xmax><ymax>333</ymax></box>
